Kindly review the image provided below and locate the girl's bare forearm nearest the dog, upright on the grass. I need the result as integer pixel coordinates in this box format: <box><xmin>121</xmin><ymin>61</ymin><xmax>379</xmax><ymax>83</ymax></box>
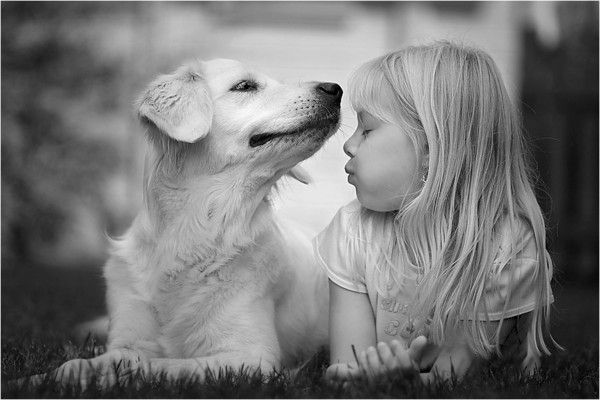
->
<box><xmin>326</xmin><ymin>280</ymin><xmax>376</xmax><ymax>379</ymax></box>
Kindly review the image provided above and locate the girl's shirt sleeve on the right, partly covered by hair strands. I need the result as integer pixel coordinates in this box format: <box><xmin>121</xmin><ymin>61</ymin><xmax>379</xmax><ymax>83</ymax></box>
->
<box><xmin>479</xmin><ymin>220</ymin><xmax>554</xmax><ymax>321</ymax></box>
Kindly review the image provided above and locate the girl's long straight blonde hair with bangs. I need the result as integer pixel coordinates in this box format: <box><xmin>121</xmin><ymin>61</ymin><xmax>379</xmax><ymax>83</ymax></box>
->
<box><xmin>349</xmin><ymin>42</ymin><xmax>553</xmax><ymax>355</ymax></box>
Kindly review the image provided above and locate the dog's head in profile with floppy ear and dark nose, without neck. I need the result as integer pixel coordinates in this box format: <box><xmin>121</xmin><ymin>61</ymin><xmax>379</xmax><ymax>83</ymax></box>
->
<box><xmin>138</xmin><ymin>60</ymin><xmax>342</xmax><ymax>180</ymax></box>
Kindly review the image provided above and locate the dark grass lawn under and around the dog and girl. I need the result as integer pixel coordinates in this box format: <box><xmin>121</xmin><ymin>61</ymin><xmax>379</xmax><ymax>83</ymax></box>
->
<box><xmin>2</xmin><ymin>266</ymin><xmax>599</xmax><ymax>398</ymax></box>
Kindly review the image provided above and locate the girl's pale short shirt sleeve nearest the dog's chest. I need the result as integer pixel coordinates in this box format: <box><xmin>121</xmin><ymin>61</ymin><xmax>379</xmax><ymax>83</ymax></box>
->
<box><xmin>313</xmin><ymin>202</ymin><xmax>367</xmax><ymax>293</ymax></box>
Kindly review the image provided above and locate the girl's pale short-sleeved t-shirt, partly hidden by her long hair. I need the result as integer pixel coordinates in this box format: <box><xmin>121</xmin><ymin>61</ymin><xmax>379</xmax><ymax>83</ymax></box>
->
<box><xmin>313</xmin><ymin>200</ymin><xmax>553</xmax><ymax>362</ymax></box>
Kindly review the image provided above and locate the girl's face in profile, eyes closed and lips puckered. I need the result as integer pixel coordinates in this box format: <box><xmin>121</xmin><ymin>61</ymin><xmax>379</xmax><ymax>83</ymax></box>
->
<box><xmin>344</xmin><ymin>111</ymin><xmax>422</xmax><ymax>212</ymax></box>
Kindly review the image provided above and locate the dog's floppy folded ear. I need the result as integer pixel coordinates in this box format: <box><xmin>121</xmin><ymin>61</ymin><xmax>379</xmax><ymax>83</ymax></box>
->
<box><xmin>138</xmin><ymin>67</ymin><xmax>213</xmax><ymax>143</ymax></box>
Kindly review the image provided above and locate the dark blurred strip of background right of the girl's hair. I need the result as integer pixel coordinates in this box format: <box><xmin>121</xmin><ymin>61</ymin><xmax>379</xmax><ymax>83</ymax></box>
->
<box><xmin>522</xmin><ymin>2</ymin><xmax>599</xmax><ymax>285</ymax></box>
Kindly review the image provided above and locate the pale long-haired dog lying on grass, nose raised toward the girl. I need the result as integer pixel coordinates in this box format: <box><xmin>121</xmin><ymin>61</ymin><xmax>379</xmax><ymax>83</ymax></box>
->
<box><xmin>24</xmin><ymin>60</ymin><xmax>342</xmax><ymax>386</ymax></box>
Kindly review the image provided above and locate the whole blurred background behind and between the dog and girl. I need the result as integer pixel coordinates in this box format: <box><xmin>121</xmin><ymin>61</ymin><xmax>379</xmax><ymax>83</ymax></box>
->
<box><xmin>1</xmin><ymin>1</ymin><xmax>599</xmax><ymax>349</ymax></box>
